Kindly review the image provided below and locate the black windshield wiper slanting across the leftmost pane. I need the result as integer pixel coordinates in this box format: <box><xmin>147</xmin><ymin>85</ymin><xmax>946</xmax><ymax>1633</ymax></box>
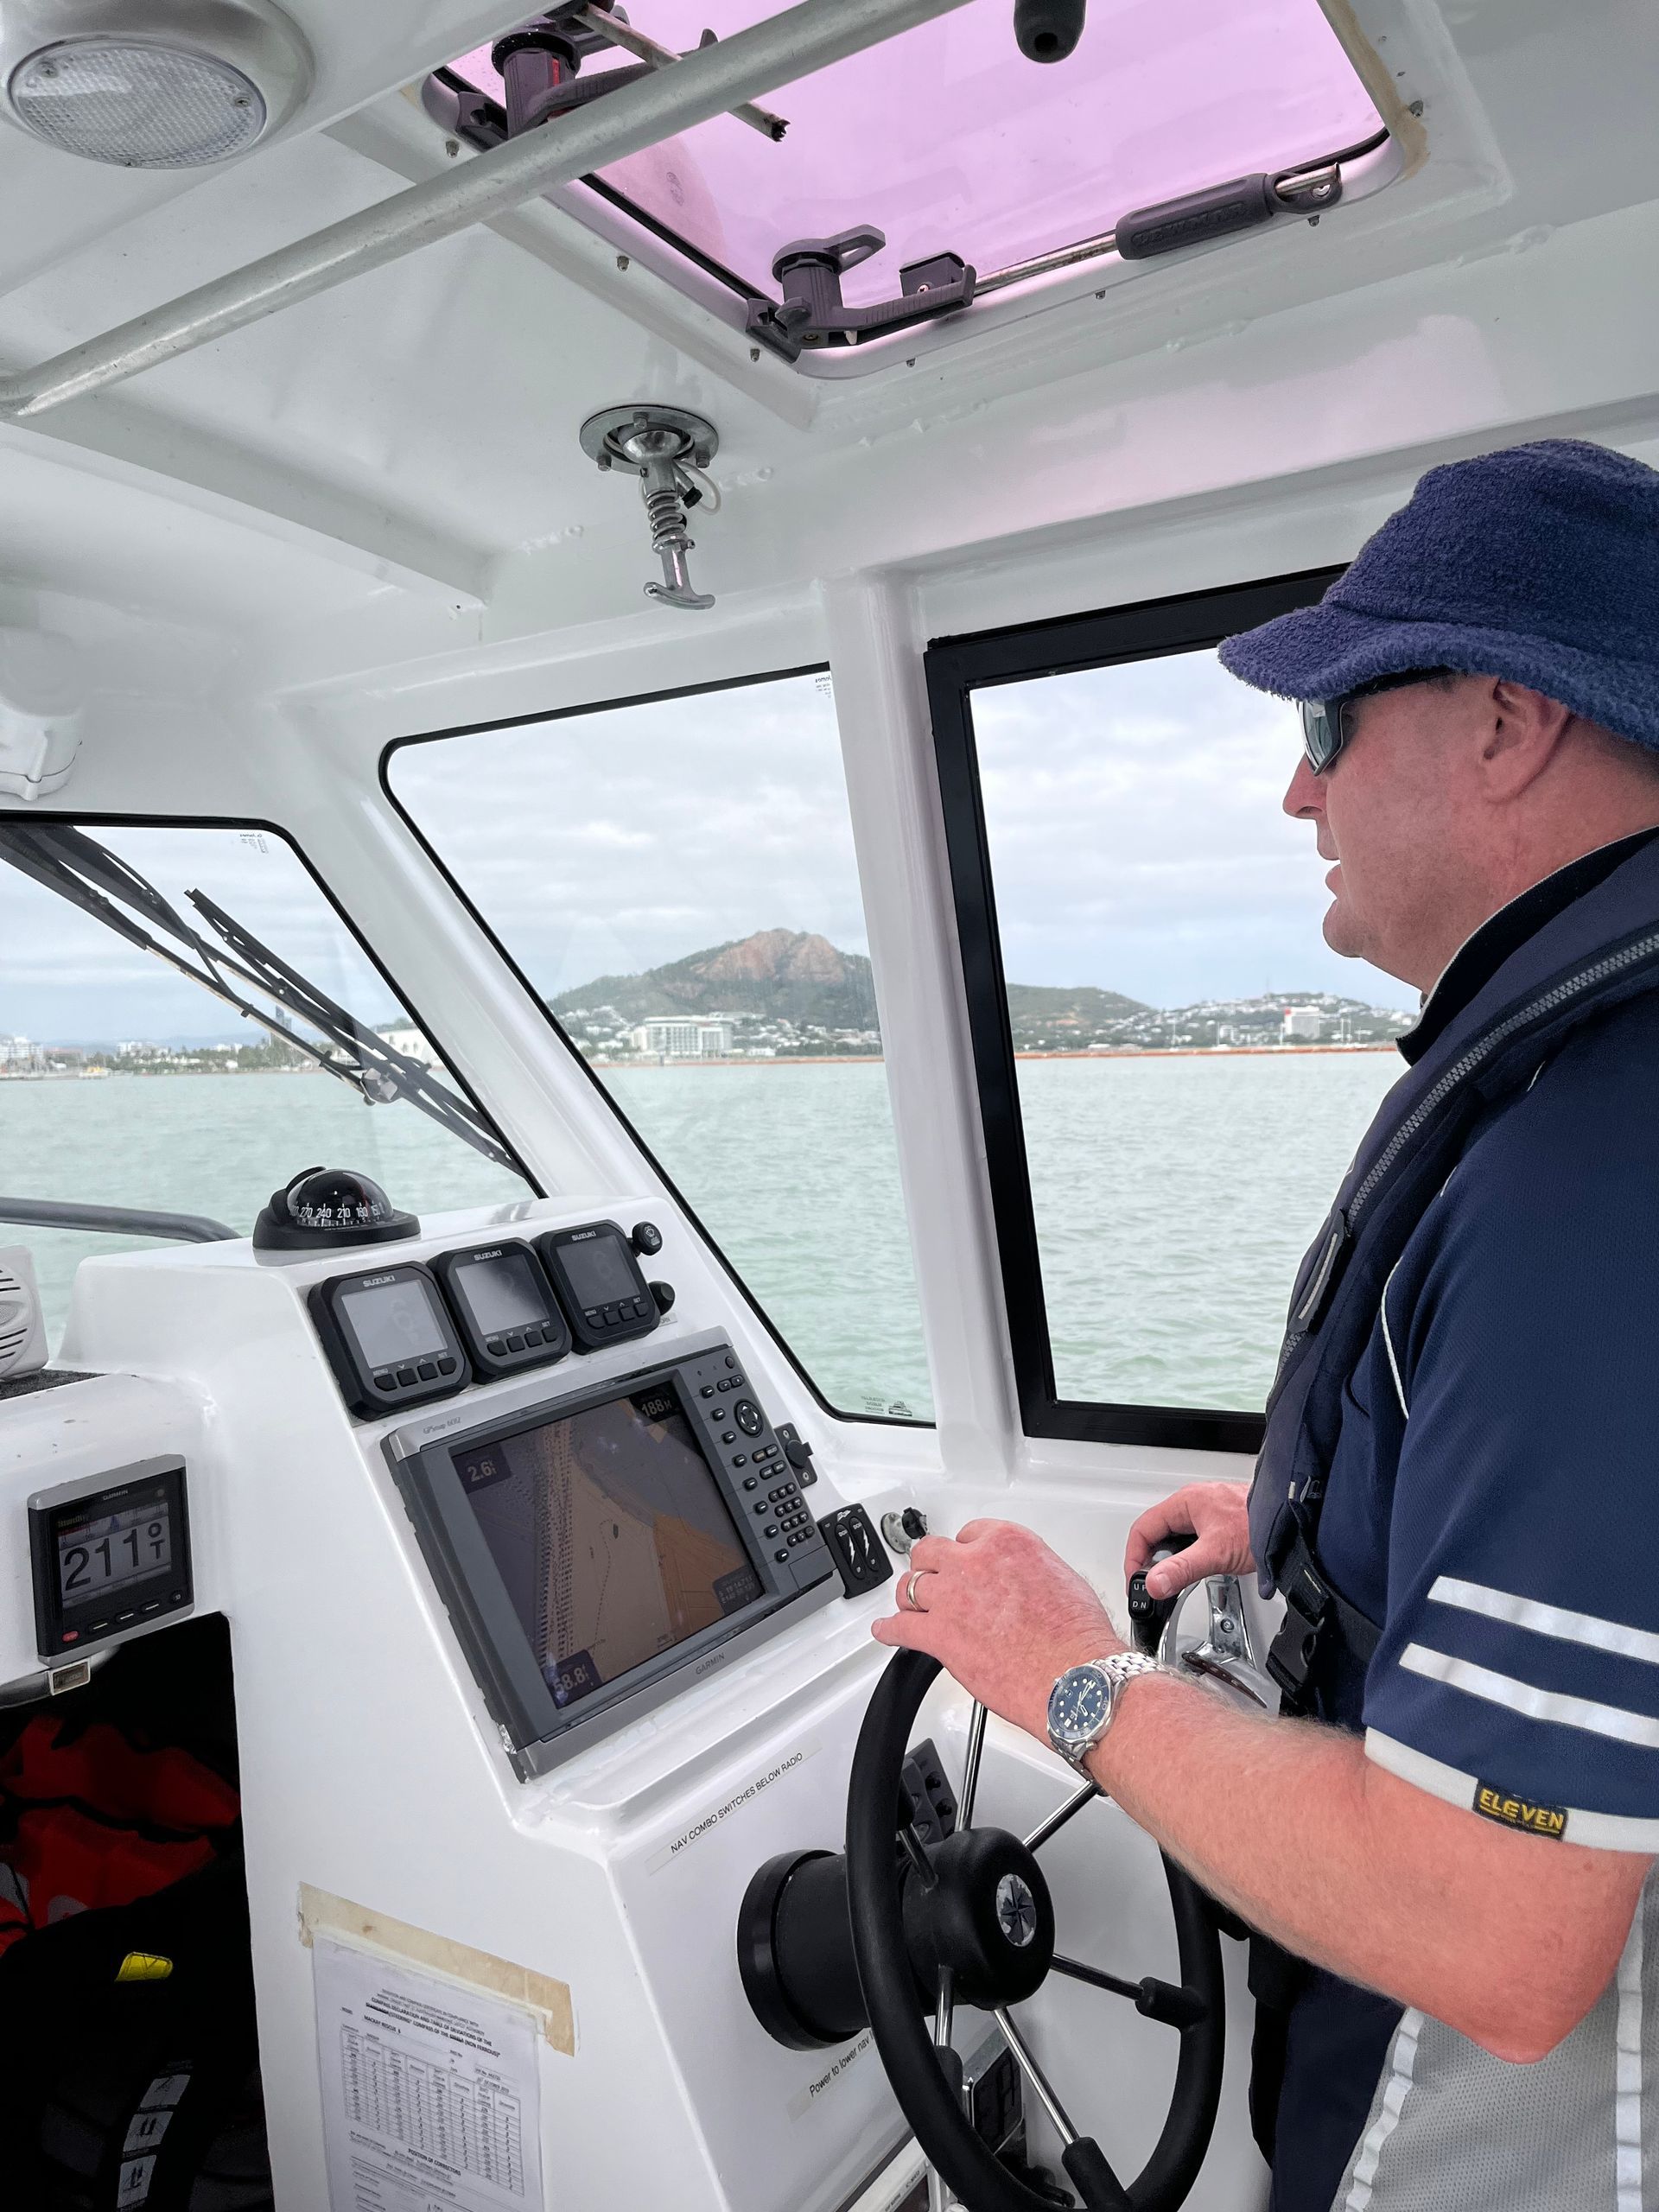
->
<box><xmin>0</xmin><ymin>818</ymin><xmax>524</xmax><ymax>1174</ymax></box>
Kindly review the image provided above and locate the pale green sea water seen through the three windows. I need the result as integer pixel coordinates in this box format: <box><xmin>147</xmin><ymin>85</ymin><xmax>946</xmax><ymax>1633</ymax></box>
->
<box><xmin>0</xmin><ymin>1051</ymin><xmax>1400</xmax><ymax>1418</ymax></box>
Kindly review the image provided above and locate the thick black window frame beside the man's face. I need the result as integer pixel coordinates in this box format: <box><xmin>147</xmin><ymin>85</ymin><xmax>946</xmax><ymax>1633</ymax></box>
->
<box><xmin>923</xmin><ymin>566</ymin><xmax>1343</xmax><ymax>1453</ymax></box>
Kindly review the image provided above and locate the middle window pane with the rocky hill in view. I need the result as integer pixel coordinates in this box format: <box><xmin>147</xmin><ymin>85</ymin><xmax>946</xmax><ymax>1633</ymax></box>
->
<box><xmin>387</xmin><ymin>675</ymin><xmax>931</xmax><ymax>1421</ymax></box>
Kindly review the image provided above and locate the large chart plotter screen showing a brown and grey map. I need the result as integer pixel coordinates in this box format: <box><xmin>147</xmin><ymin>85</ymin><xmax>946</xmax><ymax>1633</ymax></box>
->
<box><xmin>454</xmin><ymin>1385</ymin><xmax>763</xmax><ymax>1706</ymax></box>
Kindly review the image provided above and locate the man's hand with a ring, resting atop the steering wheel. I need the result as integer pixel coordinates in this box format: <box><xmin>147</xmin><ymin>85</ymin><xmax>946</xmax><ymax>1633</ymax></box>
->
<box><xmin>872</xmin><ymin>1522</ymin><xmax>1123</xmax><ymax>1743</ymax></box>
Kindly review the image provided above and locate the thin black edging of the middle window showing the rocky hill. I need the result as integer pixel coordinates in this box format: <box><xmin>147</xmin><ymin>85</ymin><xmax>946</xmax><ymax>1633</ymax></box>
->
<box><xmin>380</xmin><ymin>661</ymin><xmax>938</xmax><ymax>1431</ymax></box>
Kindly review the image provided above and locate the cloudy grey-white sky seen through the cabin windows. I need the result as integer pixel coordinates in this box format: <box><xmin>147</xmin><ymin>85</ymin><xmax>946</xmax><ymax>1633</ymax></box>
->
<box><xmin>0</xmin><ymin>652</ymin><xmax>1409</xmax><ymax>1042</ymax></box>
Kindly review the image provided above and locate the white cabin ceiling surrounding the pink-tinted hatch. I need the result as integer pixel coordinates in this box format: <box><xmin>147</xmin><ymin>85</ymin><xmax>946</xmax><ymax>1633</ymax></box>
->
<box><xmin>0</xmin><ymin>0</ymin><xmax>1659</xmax><ymax>681</ymax></box>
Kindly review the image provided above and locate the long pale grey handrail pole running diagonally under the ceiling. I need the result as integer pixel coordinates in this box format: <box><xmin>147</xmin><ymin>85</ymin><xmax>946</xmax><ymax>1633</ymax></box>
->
<box><xmin>0</xmin><ymin>0</ymin><xmax>967</xmax><ymax>423</ymax></box>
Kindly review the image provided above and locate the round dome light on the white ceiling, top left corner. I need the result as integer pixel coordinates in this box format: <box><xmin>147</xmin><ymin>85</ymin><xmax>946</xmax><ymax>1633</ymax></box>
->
<box><xmin>0</xmin><ymin>0</ymin><xmax>309</xmax><ymax>168</ymax></box>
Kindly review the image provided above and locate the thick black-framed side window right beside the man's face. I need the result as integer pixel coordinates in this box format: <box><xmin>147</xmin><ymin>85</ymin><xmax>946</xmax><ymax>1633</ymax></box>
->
<box><xmin>929</xmin><ymin>577</ymin><xmax>1415</xmax><ymax>1449</ymax></box>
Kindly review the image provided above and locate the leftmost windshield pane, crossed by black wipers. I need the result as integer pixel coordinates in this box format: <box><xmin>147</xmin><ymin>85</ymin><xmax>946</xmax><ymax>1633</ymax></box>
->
<box><xmin>0</xmin><ymin>814</ymin><xmax>529</xmax><ymax>1340</ymax></box>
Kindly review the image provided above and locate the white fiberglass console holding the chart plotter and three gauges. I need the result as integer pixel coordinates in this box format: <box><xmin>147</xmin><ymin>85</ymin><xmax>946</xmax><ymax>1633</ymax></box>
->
<box><xmin>0</xmin><ymin>1197</ymin><xmax>946</xmax><ymax>2212</ymax></box>
